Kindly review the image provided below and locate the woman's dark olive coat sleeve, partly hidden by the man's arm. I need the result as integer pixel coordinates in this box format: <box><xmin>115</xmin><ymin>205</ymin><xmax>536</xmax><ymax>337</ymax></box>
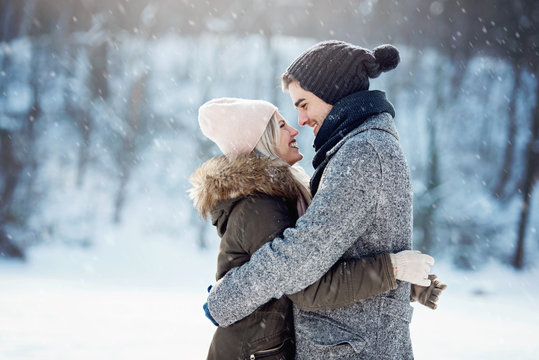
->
<box><xmin>234</xmin><ymin>196</ymin><xmax>397</xmax><ymax>310</ymax></box>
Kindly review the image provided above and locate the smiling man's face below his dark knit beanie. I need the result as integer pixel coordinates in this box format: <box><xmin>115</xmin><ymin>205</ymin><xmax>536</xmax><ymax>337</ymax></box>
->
<box><xmin>288</xmin><ymin>81</ymin><xmax>333</xmax><ymax>136</ymax></box>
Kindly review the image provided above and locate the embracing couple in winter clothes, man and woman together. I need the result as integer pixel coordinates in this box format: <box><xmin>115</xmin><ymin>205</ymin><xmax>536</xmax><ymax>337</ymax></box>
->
<box><xmin>190</xmin><ymin>41</ymin><xmax>446</xmax><ymax>360</ymax></box>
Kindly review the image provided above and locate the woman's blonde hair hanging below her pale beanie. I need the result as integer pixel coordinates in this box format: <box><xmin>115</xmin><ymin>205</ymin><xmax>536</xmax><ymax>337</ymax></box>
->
<box><xmin>253</xmin><ymin>112</ymin><xmax>311</xmax><ymax>206</ymax></box>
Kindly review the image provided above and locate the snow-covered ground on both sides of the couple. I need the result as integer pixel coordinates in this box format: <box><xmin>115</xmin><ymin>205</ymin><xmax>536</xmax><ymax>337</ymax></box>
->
<box><xmin>0</xmin><ymin>240</ymin><xmax>539</xmax><ymax>360</ymax></box>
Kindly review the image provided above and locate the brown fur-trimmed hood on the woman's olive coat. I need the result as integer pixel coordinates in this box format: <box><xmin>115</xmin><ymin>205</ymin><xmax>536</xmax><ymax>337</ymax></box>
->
<box><xmin>189</xmin><ymin>155</ymin><xmax>308</xmax><ymax>218</ymax></box>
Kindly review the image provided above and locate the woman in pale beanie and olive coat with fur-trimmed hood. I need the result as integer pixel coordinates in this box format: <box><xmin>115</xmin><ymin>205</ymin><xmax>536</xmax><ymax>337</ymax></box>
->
<box><xmin>190</xmin><ymin>98</ymin><xmax>439</xmax><ymax>359</ymax></box>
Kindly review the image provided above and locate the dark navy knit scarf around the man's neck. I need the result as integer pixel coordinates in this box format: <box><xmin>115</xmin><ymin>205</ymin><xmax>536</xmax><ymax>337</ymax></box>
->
<box><xmin>311</xmin><ymin>90</ymin><xmax>395</xmax><ymax>196</ymax></box>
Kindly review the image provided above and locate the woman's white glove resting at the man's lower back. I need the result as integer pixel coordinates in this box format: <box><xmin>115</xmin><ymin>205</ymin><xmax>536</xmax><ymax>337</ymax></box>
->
<box><xmin>389</xmin><ymin>250</ymin><xmax>434</xmax><ymax>286</ymax></box>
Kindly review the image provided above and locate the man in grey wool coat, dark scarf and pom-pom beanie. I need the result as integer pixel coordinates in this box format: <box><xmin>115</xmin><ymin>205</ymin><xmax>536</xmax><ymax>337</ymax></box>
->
<box><xmin>208</xmin><ymin>41</ymin><xmax>438</xmax><ymax>359</ymax></box>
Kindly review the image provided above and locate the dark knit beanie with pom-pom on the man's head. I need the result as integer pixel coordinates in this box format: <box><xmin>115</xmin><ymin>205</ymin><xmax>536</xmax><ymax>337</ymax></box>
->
<box><xmin>283</xmin><ymin>40</ymin><xmax>400</xmax><ymax>105</ymax></box>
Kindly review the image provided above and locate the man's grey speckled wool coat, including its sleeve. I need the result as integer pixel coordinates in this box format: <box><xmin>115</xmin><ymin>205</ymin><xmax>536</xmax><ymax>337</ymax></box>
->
<box><xmin>208</xmin><ymin>113</ymin><xmax>413</xmax><ymax>360</ymax></box>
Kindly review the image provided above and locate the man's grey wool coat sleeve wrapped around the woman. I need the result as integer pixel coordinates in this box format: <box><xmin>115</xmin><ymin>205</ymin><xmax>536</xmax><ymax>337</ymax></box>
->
<box><xmin>208</xmin><ymin>138</ymin><xmax>382</xmax><ymax>326</ymax></box>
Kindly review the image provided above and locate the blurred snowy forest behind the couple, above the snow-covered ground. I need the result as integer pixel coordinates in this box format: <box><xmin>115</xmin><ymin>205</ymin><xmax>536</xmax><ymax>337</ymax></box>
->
<box><xmin>0</xmin><ymin>0</ymin><xmax>539</xmax><ymax>270</ymax></box>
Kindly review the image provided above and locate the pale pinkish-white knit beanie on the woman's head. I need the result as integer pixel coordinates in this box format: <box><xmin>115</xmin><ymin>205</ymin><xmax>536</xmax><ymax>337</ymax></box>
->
<box><xmin>198</xmin><ymin>98</ymin><xmax>277</xmax><ymax>158</ymax></box>
